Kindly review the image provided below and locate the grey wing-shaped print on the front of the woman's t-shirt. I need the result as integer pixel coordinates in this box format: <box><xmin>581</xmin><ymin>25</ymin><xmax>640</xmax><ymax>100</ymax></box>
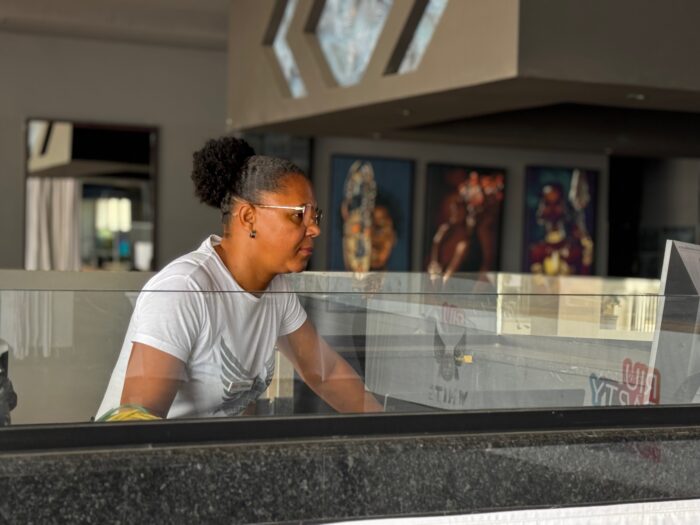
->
<box><xmin>215</xmin><ymin>337</ymin><xmax>275</xmax><ymax>416</ymax></box>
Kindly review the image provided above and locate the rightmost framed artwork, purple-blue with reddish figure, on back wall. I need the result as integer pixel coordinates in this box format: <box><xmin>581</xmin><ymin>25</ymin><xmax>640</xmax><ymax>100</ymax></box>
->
<box><xmin>523</xmin><ymin>167</ymin><xmax>598</xmax><ymax>275</ymax></box>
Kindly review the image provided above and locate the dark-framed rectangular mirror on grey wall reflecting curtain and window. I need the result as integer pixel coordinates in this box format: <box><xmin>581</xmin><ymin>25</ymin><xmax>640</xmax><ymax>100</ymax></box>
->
<box><xmin>24</xmin><ymin>119</ymin><xmax>158</xmax><ymax>271</ymax></box>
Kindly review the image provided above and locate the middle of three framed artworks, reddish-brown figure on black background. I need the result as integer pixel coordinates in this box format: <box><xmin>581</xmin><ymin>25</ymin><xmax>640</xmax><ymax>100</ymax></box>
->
<box><xmin>423</xmin><ymin>163</ymin><xmax>506</xmax><ymax>280</ymax></box>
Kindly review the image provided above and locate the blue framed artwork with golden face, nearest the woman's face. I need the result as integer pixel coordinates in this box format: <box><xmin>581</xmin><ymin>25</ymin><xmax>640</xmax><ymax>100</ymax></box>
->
<box><xmin>328</xmin><ymin>155</ymin><xmax>414</xmax><ymax>272</ymax></box>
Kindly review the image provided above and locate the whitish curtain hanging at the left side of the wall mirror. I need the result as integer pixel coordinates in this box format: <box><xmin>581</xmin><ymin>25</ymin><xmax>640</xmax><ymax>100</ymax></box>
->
<box><xmin>24</xmin><ymin>177</ymin><xmax>82</xmax><ymax>271</ymax></box>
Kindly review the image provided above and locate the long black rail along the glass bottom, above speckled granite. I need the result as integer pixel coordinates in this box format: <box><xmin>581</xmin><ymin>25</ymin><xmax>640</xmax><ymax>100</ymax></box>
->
<box><xmin>0</xmin><ymin>405</ymin><xmax>700</xmax><ymax>457</ymax></box>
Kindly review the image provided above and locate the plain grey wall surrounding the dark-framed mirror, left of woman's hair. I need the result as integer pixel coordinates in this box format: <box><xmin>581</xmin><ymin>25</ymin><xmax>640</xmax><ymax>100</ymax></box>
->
<box><xmin>0</xmin><ymin>31</ymin><xmax>226</xmax><ymax>268</ymax></box>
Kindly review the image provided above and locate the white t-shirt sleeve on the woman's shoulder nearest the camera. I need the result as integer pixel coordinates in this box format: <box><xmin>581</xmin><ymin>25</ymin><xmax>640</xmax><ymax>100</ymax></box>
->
<box><xmin>131</xmin><ymin>276</ymin><xmax>206</xmax><ymax>363</ymax></box>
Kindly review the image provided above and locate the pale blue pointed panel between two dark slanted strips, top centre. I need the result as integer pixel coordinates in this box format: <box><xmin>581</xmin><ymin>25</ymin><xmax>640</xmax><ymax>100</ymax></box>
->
<box><xmin>316</xmin><ymin>0</ymin><xmax>393</xmax><ymax>86</ymax></box>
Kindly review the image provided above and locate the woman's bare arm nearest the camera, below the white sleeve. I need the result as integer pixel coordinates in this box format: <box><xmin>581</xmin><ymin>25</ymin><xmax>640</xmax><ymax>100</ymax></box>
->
<box><xmin>121</xmin><ymin>343</ymin><xmax>185</xmax><ymax>418</ymax></box>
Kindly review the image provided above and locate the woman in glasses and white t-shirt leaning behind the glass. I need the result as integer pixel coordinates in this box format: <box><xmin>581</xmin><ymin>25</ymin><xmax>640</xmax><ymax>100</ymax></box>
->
<box><xmin>97</xmin><ymin>137</ymin><xmax>381</xmax><ymax>420</ymax></box>
